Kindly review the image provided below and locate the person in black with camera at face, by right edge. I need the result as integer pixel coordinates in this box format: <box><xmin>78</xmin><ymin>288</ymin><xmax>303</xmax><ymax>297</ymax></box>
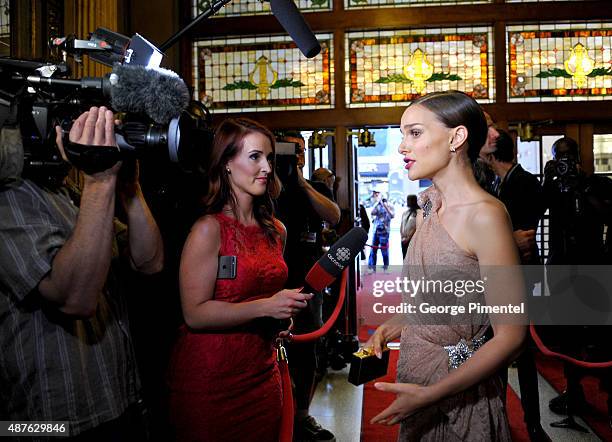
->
<box><xmin>543</xmin><ymin>137</ymin><xmax>612</xmax><ymax>427</ymax></box>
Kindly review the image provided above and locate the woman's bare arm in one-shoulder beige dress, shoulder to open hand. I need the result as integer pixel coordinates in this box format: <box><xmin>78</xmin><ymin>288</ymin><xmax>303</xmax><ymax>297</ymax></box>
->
<box><xmin>372</xmin><ymin>203</ymin><xmax>526</xmax><ymax>425</ymax></box>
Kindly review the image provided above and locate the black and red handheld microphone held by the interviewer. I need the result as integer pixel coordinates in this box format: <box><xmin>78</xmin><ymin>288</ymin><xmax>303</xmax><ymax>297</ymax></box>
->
<box><xmin>306</xmin><ymin>227</ymin><xmax>368</xmax><ymax>291</ymax></box>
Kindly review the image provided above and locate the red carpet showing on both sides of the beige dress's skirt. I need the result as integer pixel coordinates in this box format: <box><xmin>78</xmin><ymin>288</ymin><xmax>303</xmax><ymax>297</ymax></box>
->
<box><xmin>359</xmin><ymin>326</ymin><xmax>529</xmax><ymax>442</ymax></box>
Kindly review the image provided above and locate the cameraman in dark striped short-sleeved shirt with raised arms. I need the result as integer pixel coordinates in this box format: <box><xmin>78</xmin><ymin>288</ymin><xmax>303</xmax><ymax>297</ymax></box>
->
<box><xmin>0</xmin><ymin>107</ymin><xmax>163</xmax><ymax>441</ymax></box>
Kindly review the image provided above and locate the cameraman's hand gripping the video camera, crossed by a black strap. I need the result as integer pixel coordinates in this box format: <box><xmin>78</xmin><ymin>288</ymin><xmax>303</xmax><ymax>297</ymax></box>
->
<box><xmin>55</xmin><ymin>106</ymin><xmax>121</xmax><ymax>176</ymax></box>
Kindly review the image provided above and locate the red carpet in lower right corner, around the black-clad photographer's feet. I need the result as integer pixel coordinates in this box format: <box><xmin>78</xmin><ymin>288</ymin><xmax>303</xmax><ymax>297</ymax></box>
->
<box><xmin>536</xmin><ymin>353</ymin><xmax>612</xmax><ymax>440</ymax></box>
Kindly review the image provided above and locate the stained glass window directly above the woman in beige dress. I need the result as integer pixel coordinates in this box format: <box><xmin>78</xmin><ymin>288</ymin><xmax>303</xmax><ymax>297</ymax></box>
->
<box><xmin>346</xmin><ymin>27</ymin><xmax>495</xmax><ymax>107</ymax></box>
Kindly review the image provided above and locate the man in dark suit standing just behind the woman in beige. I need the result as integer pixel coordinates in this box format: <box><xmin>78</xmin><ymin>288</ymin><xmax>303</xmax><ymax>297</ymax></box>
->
<box><xmin>487</xmin><ymin>130</ymin><xmax>550</xmax><ymax>441</ymax></box>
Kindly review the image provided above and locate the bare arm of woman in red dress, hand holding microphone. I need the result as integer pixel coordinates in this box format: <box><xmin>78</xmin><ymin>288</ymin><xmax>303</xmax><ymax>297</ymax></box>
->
<box><xmin>179</xmin><ymin>217</ymin><xmax>312</xmax><ymax>330</ymax></box>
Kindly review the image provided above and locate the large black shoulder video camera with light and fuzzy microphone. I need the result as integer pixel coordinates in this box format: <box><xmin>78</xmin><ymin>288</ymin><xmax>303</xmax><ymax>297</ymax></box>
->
<box><xmin>0</xmin><ymin>28</ymin><xmax>213</xmax><ymax>181</ymax></box>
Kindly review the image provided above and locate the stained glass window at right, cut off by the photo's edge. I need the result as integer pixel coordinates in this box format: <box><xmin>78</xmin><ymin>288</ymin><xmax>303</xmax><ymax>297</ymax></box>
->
<box><xmin>506</xmin><ymin>22</ymin><xmax>612</xmax><ymax>102</ymax></box>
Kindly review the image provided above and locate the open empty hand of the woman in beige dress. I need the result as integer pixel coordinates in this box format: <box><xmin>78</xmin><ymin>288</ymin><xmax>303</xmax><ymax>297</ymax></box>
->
<box><xmin>370</xmin><ymin>382</ymin><xmax>435</xmax><ymax>425</ymax></box>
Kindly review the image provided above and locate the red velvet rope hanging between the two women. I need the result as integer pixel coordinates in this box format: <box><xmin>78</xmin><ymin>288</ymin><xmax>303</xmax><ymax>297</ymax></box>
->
<box><xmin>278</xmin><ymin>268</ymin><xmax>348</xmax><ymax>442</ymax></box>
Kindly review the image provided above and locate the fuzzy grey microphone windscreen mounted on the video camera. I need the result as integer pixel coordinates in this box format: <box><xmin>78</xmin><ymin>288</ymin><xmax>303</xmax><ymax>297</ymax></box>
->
<box><xmin>111</xmin><ymin>64</ymin><xmax>190</xmax><ymax>124</ymax></box>
